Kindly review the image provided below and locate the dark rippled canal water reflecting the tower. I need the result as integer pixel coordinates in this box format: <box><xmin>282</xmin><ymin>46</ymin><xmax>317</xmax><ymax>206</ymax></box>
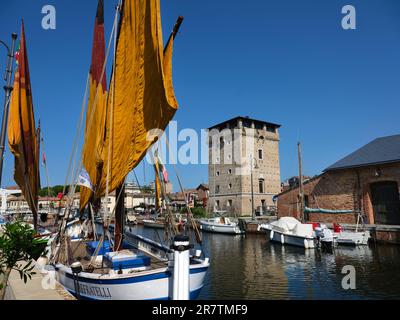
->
<box><xmin>137</xmin><ymin>227</ymin><xmax>400</xmax><ymax>300</ymax></box>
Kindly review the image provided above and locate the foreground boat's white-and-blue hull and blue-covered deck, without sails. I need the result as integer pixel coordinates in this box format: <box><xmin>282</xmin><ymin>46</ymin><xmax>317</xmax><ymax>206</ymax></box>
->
<box><xmin>55</xmin><ymin>242</ymin><xmax>209</xmax><ymax>300</ymax></box>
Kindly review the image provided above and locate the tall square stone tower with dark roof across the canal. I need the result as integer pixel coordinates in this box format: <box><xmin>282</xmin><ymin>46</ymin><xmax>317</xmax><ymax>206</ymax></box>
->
<box><xmin>208</xmin><ymin>117</ymin><xmax>281</xmax><ymax>216</ymax></box>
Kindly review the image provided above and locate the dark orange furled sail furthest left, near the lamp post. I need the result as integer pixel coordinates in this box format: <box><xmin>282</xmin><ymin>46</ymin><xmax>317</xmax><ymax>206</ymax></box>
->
<box><xmin>8</xmin><ymin>22</ymin><xmax>39</xmax><ymax>230</ymax></box>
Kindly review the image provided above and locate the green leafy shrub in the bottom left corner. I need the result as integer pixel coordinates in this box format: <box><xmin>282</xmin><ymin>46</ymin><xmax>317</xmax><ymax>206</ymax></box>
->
<box><xmin>0</xmin><ymin>221</ymin><xmax>47</xmax><ymax>300</ymax></box>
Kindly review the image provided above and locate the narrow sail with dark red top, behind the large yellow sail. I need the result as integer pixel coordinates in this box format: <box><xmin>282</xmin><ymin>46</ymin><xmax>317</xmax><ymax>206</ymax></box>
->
<box><xmin>80</xmin><ymin>0</ymin><xmax>107</xmax><ymax>211</ymax></box>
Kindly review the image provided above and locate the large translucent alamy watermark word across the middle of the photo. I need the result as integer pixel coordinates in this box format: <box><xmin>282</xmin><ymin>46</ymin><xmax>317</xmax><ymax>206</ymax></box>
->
<box><xmin>146</xmin><ymin>121</ymin><xmax>264</xmax><ymax>175</ymax></box>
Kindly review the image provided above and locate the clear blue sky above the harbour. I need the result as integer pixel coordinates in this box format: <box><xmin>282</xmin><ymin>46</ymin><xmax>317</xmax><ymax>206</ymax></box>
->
<box><xmin>0</xmin><ymin>0</ymin><xmax>400</xmax><ymax>189</ymax></box>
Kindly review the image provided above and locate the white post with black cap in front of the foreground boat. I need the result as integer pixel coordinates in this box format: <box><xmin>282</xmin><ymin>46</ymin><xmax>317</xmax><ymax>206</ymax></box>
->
<box><xmin>172</xmin><ymin>235</ymin><xmax>193</xmax><ymax>300</ymax></box>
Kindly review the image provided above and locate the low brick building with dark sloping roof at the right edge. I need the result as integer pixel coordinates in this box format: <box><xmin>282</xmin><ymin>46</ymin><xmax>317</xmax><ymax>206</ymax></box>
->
<box><xmin>278</xmin><ymin>135</ymin><xmax>400</xmax><ymax>225</ymax></box>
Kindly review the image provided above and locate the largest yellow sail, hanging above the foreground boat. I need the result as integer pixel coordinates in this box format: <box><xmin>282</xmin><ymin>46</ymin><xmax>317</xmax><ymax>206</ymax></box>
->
<box><xmin>96</xmin><ymin>0</ymin><xmax>178</xmax><ymax>197</ymax></box>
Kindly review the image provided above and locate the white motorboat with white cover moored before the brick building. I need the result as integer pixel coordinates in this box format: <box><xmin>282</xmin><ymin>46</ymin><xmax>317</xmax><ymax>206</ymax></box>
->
<box><xmin>258</xmin><ymin>217</ymin><xmax>316</xmax><ymax>249</ymax></box>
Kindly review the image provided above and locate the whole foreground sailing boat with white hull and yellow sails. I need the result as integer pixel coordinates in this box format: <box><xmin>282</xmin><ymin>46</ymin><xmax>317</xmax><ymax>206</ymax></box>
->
<box><xmin>51</xmin><ymin>0</ymin><xmax>209</xmax><ymax>300</ymax></box>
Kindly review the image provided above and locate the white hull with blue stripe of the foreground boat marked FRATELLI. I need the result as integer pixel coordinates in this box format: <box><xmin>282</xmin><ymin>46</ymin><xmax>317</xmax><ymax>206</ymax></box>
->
<box><xmin>56</xmin><ymin>262</ymin><xmax>209</xmax><ymax>300</ymax></box>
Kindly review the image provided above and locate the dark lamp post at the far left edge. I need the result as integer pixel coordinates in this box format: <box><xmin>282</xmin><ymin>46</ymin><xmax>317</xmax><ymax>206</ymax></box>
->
<box><xmin>0</xmin><ymin>33</ymin><xmax>17</xmax><ymax>186</ymax></box>
